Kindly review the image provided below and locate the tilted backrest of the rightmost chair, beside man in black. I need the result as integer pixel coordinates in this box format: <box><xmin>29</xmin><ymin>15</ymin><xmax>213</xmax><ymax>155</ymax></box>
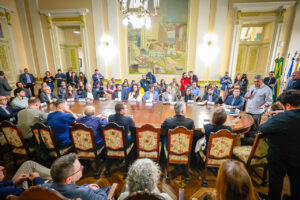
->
<box><xmin>247</xmin><ymin>134</ymin><xmax>269</xmax><ymax>164</ymax></box>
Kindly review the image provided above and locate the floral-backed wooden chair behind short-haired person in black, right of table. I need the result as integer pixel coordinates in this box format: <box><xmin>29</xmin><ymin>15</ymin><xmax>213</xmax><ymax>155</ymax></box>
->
<box><xmin>200</xmin><ymin>129</ymin><xmax>236</xmax><ymax>187</ymax></box>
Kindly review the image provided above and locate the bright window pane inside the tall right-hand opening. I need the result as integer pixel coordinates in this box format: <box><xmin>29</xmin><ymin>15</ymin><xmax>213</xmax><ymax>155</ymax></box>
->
<box><xmin>240</xmin><ymin>26</ymin><xmax>264</xmax><ymax>42</ymax></box>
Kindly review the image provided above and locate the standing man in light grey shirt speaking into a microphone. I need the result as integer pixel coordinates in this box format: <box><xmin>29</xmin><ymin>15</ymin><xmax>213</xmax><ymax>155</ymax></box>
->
<box><xmin>245</xmin><ymin>75</ymin><xmax>272</xmax><ymax>132</ymax></box>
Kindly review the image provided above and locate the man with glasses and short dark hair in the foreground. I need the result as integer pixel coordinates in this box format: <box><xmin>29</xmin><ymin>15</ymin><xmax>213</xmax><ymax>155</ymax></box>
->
<box><xmin>42</xmin><ymin>153</ymin><xmax>110</xmax><ymax>200</ymax></box>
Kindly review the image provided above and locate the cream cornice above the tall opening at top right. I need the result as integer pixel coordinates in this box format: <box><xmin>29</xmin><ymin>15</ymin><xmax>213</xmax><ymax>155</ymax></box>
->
<box><xmin>232</xmin><ymin>1</ymin><xmax>296</xmax><ymax>12</ymax></box>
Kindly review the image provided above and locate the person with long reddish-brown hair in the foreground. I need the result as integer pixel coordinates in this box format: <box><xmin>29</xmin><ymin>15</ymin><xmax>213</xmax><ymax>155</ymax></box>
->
<box><xmin>203</xmin><ymin>160</ymin><xmax>257</xmax><ymax>200</ymax></box>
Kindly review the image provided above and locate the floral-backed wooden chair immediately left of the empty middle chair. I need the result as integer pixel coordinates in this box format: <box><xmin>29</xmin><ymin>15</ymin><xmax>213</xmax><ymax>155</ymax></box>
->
<box><xmin>102</xmin><ymin>123</ymin><xmax>134</xmax><ymax>177</ymax></box>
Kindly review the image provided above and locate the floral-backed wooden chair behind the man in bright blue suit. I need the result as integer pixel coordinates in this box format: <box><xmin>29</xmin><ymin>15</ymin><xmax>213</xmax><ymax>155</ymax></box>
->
<box><xmin>31</xmin><ymin>122</ymin><xmax>72</xmax><ymax>158</ymax></box>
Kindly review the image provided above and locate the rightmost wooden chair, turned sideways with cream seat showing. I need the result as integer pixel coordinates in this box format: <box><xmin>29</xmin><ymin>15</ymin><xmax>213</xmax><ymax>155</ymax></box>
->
<box><xmin>233</xmin><ymin>134</ymin><xmax>269</xmax><ymax>185</ymax></box>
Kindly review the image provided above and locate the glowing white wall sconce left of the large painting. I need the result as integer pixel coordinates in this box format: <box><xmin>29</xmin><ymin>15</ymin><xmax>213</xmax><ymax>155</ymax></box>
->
<box><xmin>99</xmin><ymin>35</ymin><xmax>117</xmax><ymax>62</ymax></box>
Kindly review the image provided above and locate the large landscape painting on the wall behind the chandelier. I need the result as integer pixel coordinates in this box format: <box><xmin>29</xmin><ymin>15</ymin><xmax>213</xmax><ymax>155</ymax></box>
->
<box><xmin>127</xmin><ymin>0</ymin><xmax>189</xmax><ymax>75</ymax></box>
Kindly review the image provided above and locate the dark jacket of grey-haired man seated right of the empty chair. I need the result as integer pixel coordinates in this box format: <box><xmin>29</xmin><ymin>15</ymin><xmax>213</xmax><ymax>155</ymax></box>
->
<box><xmin>161</xmin><ymin>115</ymin><xmax>195</xmax><ymax>131</ymax></box>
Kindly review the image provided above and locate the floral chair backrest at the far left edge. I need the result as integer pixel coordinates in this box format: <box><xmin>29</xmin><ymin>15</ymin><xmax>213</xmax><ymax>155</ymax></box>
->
<box><xmin>0</xmin><ymin>120</ymin><xmax>25</xmax><ymax>148</ymax></box>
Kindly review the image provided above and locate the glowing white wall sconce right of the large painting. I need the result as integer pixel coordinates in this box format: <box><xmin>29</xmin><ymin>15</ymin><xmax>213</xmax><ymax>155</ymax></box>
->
<box><xmin>197</xmin><ymin>34</ymin><xmax>219</xmax><ymax>64</ymax></box>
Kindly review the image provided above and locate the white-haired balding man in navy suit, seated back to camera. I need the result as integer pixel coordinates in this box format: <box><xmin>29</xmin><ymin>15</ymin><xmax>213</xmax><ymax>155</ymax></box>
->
<box><xmin>76</xmin><ymin>106</ymin><xmax>107</xmax><ymax>149</ymax></box>
